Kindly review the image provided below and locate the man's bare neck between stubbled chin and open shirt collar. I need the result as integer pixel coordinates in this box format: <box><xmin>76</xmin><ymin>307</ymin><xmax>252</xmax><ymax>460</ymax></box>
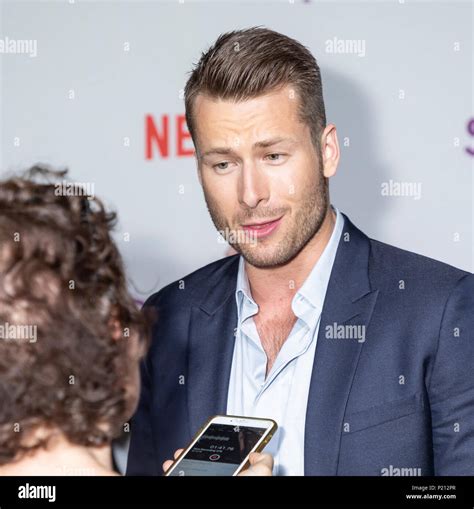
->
<box><xmin>245</xmin><ymin>207</ymin><xmax>336</xmax><ymax>306</ymax></box>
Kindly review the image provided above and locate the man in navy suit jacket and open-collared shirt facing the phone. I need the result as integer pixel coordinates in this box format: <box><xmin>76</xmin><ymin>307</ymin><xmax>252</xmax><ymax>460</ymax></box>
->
<box><xmin>128</xmin><ymin>28</ymin><xmax>474</xmax><ymax>475</ymax></box>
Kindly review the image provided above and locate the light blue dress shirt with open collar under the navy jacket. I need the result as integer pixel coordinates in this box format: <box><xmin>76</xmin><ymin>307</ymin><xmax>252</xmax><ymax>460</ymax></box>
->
<box><xmin>227</xmin><ymin>207</ymin><xmax>344</xmax><ymax>475</ymax></box>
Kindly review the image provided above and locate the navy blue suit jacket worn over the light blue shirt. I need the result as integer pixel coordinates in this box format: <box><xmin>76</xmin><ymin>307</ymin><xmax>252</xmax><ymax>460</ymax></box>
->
<box><xmin>127</xmin><ymin>212</ymin><xmax>474</xmax><ymax>476</ymax></box>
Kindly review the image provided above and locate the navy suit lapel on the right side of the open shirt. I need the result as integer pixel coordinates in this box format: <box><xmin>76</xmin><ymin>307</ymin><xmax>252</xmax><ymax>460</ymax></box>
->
<box><xmin>304</xmin><ymin>216</ymin><xmax>378</xmax><ymax>475</ymax></box>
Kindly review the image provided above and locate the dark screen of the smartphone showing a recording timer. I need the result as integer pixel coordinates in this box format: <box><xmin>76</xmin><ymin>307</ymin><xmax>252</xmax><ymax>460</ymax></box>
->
<box><xmin>170</xmin><ymin>424</ymin><xmax>265</xmax><ymax>476</ymax></box>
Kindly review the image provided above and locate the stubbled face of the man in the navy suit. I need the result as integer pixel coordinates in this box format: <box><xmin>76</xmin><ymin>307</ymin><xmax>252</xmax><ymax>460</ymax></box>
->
<box><xmin>194</xmin><ymin>87</ymin><xmax>329</xmax><ymax>267</ymax></box>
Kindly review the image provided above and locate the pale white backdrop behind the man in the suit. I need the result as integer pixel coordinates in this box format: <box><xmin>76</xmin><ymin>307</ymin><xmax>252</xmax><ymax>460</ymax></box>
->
<box><xmin>0</xmin><ymin>0</ymin><xmax>474</xmax><ymax>476</ymax></box>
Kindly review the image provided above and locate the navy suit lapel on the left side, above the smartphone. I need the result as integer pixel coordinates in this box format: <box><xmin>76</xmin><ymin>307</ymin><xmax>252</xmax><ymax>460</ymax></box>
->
<box><xmin>187</xmin><ymin>256</ymin><xmax>239</xmax><ymax>436</ymax></box>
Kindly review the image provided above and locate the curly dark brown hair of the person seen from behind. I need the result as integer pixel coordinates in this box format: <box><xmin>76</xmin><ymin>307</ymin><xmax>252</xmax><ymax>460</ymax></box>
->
<box><xmin>0</xmin><ymin>165</ymin><xmax>151</xmax><ymax>465</ymax></box>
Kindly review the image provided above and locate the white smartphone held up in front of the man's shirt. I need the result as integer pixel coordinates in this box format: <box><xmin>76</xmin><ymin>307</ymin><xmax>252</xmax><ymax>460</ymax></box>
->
<box><xmin>165</xmin><ymin>415</ymin><xmax>277</xmax><ymax>476</ymax></box>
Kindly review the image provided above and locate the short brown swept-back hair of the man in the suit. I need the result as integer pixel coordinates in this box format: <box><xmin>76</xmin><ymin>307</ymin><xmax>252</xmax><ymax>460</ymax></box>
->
<box><xmin>184</xmin><ymin>27</ymin><xmax>326</xmax><ymax>148</ymax></box>
